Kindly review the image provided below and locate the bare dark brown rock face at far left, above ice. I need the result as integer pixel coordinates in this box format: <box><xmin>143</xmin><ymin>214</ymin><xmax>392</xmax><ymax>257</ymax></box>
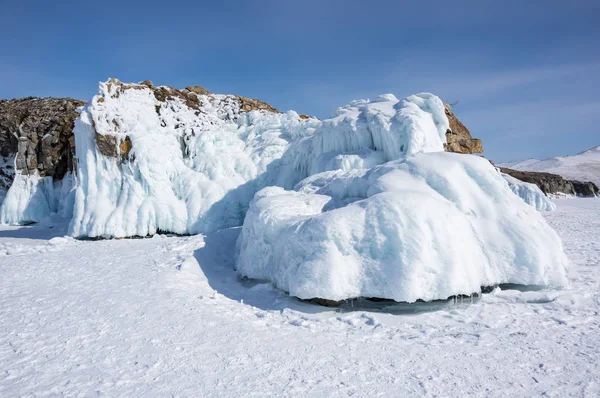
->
<box><xmin>0</xmin><ymin>97</ymin><xmax>85</xmax><ymax>179</ymax></box>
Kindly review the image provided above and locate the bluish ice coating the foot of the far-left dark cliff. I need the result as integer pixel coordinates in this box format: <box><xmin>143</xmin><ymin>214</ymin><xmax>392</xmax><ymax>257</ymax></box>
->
<box><xmin>0</xmin><ymin>172</ymin><xmax>75</xmax><ymax>224</ymax></box>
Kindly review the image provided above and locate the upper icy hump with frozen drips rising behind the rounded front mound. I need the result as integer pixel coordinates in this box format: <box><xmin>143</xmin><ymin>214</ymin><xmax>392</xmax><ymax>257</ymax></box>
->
<box><xmin>284</xmin><ymin>93</ymin><xmax>449</xmax><ymax>177</ymax></box>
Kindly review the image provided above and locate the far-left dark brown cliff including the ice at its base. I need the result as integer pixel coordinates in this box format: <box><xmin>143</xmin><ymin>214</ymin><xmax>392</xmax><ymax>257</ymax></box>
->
<box><xmin>0</xmin><ymin>97</ymin><xmax>85</xmax><ymax>224</ymax></box>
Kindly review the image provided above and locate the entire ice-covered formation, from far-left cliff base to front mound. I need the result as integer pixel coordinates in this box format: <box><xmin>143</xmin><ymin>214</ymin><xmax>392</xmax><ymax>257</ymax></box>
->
<box><xmin>0</xmin><ymin>79</ymin><xmax>567</xmax><ymax>301</ymax></box>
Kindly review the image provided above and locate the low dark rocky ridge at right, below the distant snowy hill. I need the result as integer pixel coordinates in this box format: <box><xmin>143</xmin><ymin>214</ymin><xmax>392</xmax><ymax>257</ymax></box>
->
<box><xmin>500</xmin><ymin>167</ymin><xmax>599</xmax><ymax>196</ymax></box>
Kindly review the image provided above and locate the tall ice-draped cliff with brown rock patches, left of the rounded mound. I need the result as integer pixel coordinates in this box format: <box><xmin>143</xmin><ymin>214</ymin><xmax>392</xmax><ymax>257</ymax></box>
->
<box><xmin>70</xmin><ymin>79</ymin><xmax>319</xmax><ymax>237</ymax></box>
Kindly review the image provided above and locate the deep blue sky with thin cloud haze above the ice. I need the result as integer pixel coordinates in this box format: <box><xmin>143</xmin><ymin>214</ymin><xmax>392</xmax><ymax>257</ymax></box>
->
<box><xmin>0</xmin><ymin>0</ymin><xmax>600</xmax><ymax>161</ymax></box>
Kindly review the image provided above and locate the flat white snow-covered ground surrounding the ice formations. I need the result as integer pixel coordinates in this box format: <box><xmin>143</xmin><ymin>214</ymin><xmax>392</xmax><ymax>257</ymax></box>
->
<box><xmin>0</xmin><ymin>199</ymin><xmax>600</xmax><ymax>397</ymax></box>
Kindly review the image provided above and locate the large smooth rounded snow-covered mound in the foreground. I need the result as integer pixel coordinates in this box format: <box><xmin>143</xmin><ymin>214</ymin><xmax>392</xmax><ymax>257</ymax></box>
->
<box><xmin>236</xmin><ymin>153</ymin><xmax>568</xmax><ymax>302</ymax></box>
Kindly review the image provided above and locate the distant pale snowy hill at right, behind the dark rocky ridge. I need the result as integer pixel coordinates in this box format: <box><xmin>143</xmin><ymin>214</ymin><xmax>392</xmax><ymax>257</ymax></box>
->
<box><xmin>500</xmin><ymin>146</ymin><xmax>600</xmax><ymax>185</ymax></box>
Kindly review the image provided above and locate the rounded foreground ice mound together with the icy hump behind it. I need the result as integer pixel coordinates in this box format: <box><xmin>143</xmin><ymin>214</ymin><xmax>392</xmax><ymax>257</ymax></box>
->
<box><xmin>237</xmin><ymin>94</ymin><xmax>568</xmax><ymax>302</ymax></box>
